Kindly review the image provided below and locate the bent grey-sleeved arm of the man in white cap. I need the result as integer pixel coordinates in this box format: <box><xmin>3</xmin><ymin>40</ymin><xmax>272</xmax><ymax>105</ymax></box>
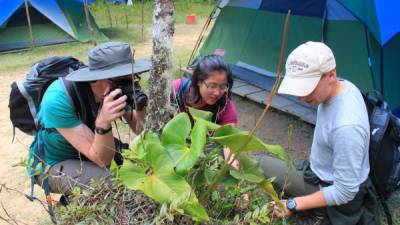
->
<box><xmin>274</xmin><ymin>126</ymin><xmax>369</xmax><ymax>217</ymax></box>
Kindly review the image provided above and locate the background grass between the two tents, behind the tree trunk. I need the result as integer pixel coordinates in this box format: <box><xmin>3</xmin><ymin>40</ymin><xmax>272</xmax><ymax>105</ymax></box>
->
<box><xmin>0</xmin><ymin>0</ymin><xmax>215</xmax><ymax>76</ymax></box>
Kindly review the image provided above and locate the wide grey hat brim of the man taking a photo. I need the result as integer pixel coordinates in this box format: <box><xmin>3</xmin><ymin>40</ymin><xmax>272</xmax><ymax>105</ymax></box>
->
<box><xmin>65</xmin><ymin>59</ymin><xmax>151</xmax><ymax>82</ymax></box>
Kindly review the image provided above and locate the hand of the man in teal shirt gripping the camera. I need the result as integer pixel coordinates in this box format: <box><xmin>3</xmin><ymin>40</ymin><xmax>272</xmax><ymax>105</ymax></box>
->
<box><xmin>96</xmin><ymin>88</ymin><xmax>127</xmax><ymax>128</ymax></box>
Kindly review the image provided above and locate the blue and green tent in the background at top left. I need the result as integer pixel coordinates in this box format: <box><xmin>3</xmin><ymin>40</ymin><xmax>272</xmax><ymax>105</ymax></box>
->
<box><xmin>0</xmin><ymin>0</ymin><xmax>108</xmax><ymax>52</ymax></box>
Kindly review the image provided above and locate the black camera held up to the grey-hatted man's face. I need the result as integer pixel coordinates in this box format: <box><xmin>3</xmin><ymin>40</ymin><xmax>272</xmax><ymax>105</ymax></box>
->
<box><xmin>113</xmin><ymin>79</ymin><xmax>147</xmax><ymax>110</ymax></box>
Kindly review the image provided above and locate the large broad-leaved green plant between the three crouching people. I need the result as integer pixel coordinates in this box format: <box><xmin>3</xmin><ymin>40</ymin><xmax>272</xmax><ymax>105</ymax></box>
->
<box><xmin>119</xmin><ymin>109</ymin><xmax>288</xmax><ymax>223</ymax></box>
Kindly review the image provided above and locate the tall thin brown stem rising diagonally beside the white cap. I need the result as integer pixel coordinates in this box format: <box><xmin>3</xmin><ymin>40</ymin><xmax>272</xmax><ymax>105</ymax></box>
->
<box><xmin>200</xmin><ymin>10</ymin><xmax>291</xmax><ymax>204</ymax></box>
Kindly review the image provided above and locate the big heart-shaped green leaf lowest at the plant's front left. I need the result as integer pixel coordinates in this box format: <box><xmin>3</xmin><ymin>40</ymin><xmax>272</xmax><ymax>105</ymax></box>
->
<box><xmin>119</xmin><ymin>129</ymin><xmax>208</xmax><ymax>221</ymax></box>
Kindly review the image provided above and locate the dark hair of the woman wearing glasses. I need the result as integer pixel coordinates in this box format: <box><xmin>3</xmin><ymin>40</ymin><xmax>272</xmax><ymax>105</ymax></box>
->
<box><xmin>187</xmin><ymin>55</ymin><xmax>233</xmax><ymax>103</ymax></box>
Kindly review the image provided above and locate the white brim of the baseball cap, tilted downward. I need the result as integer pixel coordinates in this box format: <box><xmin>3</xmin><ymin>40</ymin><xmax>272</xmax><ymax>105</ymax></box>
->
<box><xmin>278</xmin><ymin>76</ymin><xmax>321</xmax><ymax>97</ymax></box>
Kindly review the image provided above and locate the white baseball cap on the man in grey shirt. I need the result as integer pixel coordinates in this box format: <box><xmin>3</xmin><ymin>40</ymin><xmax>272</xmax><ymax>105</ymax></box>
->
<box><xmin>278</xmin><ymin>41</ymin><xmax>336</xmax><ymax>96</ymax></box>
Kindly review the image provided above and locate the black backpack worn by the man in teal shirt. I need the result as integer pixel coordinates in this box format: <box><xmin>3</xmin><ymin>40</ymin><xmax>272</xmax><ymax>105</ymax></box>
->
<box><xmin>8</xmin><ymin>56</ymin><xmax>85</xmax><ymax>136</ymax></box>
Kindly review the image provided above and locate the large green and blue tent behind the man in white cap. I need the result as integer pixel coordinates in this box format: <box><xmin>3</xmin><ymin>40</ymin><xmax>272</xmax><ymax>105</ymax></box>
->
<box><xmin>199</xmin><ymin>0</ymin><xmax>400</xmax><ymax>108</ymax></box>
